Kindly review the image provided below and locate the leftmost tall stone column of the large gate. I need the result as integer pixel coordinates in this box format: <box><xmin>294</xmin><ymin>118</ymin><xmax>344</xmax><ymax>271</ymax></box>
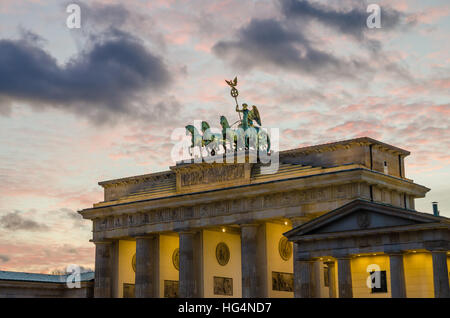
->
<box><xmin>94</xmin><ymin>241</ymin><xmax>113</xmax><ymax>298</ymax></box>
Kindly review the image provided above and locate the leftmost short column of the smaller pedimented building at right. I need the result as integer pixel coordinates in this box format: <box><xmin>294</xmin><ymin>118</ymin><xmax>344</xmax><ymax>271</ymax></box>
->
<box><xmin>294</xmin><ymin>258</ymin><xmax>315</xmax><ymax>298</ymax></box>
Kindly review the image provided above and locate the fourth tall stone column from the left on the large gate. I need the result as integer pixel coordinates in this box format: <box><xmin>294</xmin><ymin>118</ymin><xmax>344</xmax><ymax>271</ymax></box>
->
<box><xmin>241</xmin><ymin>224</ymin><xmax>267</xmax><ymax>298</ymax></box>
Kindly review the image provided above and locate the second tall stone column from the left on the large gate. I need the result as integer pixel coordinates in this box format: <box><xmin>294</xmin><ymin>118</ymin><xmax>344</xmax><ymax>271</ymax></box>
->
<box><xmin>135</xmin><ymin>235</ymin><xmax>159</xmax><ymax>298</ymax></box>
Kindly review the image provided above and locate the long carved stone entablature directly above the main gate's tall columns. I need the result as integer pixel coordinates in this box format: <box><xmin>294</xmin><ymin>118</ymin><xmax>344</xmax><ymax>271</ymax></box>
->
<box><xmin>82</xmin><ymin>169</ymin><xmax>427</xmax><ymax>240</ymax></box>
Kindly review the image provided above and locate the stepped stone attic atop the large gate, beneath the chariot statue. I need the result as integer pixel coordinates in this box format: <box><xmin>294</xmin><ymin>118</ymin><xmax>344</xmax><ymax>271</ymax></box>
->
<box><xmin>95</xmin><ymin>137</ymin><xmax>409</xmax><ymax>206</ymax></box>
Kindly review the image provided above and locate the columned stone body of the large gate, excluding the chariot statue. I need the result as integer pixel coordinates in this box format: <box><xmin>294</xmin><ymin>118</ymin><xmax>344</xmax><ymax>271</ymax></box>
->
<box><xmin>80</xmin><ymin>138</ymin><xmax>429</xmax><ymax>297</ymax></box>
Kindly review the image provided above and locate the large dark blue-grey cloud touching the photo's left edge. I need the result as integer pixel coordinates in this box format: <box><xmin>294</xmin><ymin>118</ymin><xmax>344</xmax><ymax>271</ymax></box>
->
<box><xmin>0</xmin><ymin>29</ymin><xmax>172</xmax><ymax>123</ymax></box>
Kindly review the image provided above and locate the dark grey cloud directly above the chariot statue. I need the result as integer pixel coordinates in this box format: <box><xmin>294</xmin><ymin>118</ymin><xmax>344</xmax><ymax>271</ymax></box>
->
<box><xmin>213</xmin><ymin>19</ymin><xmax>367</xmax><ymax>76</ymax></box>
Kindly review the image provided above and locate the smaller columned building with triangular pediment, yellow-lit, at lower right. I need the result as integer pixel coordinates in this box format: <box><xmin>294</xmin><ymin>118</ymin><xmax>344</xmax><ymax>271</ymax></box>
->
<box><xmin>285</xmin><ymin>200</ymin><xmax>450</xmax><ymax>298</ymax></box>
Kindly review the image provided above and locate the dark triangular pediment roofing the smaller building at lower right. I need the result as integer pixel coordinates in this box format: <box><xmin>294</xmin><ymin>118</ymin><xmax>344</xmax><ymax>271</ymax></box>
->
<box><xmin>285</xmin><ymin>200</ymin><xmax>449</xmax><ymax>237</ymax></box>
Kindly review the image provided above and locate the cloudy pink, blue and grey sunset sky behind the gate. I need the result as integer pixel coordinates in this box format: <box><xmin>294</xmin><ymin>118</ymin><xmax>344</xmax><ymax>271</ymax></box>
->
<box><xmin>0</xmin><ymin>0</ymin><xmax>450</xmax><ymax>273</ymax></box>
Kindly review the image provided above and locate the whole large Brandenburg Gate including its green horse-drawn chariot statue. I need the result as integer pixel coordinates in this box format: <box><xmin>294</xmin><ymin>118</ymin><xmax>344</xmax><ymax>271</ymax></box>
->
<box><xmin>79</xmin><ymin>78</ymin><xmax>440</xmax><ymax>297</ymax></box>
